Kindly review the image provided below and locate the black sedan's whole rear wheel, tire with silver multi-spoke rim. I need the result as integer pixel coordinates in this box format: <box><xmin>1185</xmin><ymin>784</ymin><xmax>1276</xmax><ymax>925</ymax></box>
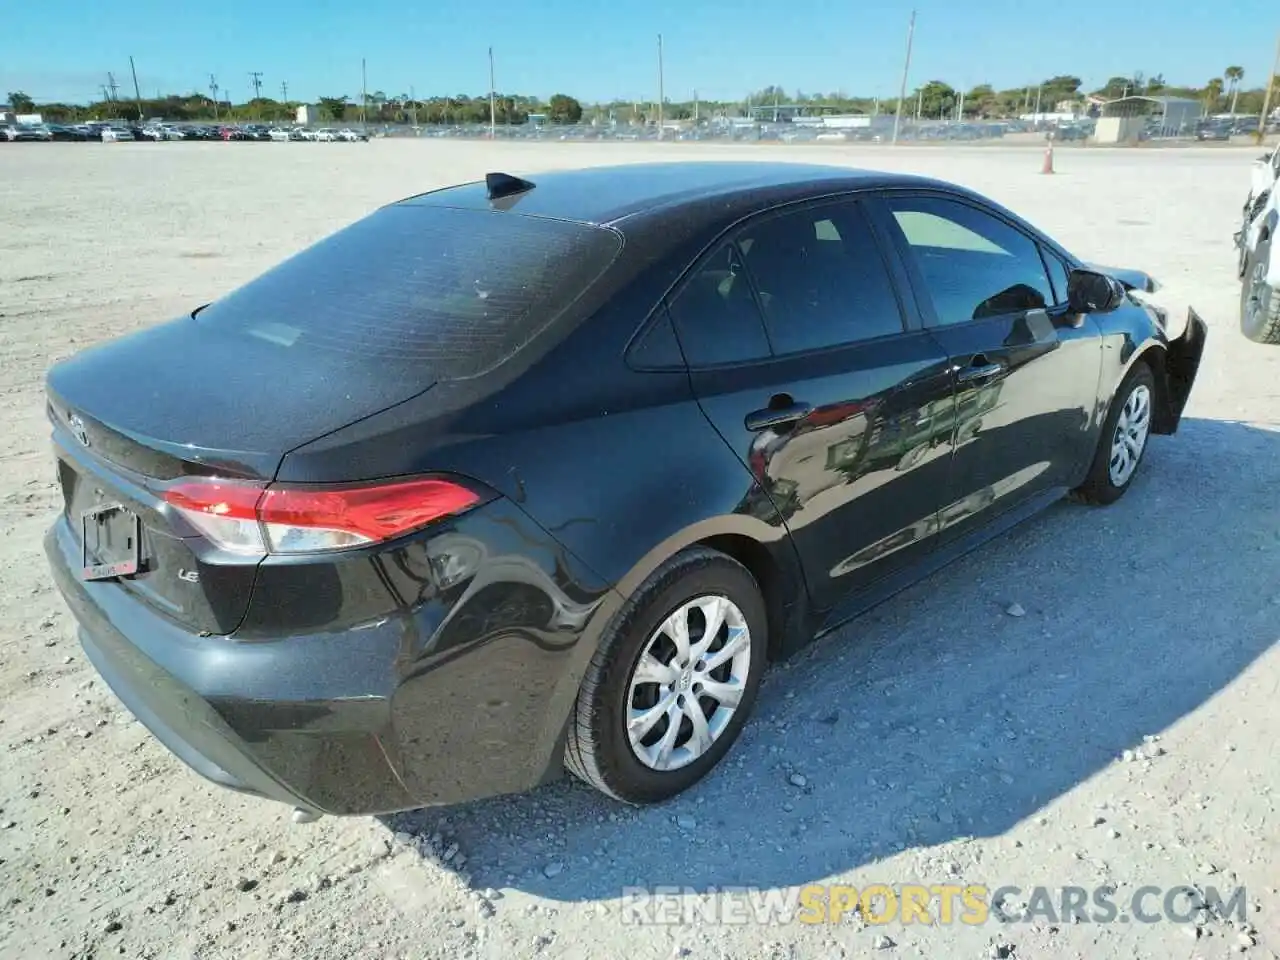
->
<box><xmin>564</xmin><ymin>547</ymin><xmax>768</xmax><ymax>804</ymax></box>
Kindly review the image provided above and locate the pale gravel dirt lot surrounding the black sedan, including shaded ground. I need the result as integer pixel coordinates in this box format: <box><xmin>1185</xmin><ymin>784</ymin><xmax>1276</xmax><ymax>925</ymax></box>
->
<box><xmin>0</xmin><ymin>141</ymin><xmax>1280</xmax><ymax>960</ymax></box>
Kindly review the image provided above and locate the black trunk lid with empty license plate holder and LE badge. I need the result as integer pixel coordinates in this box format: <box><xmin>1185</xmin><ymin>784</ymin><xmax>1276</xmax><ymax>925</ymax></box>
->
<box><xmin>47</xmin><ymin>317</ymin><xmax>433</xmax><ymax>634</ymax></box>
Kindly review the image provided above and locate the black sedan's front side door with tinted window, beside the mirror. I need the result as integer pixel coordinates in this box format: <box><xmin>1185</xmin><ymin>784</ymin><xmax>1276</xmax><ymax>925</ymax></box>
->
<box><xmin>881</xmin><ymin>193</ymin><xmax>1101</xmax><ymax>543</ymax></box>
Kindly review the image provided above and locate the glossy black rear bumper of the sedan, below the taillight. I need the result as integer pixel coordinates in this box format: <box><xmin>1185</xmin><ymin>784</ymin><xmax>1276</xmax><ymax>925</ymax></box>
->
<box><xmin>45</xmin><ymin>504</ymin><xmax>616</xmax><ymax>814</ymax></box>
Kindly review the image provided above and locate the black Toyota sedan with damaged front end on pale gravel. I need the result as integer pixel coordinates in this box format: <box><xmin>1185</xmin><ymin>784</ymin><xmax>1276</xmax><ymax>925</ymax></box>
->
<box><xmin>37</xmin><ymin>163</ymin><xmax>1206</xmax><ymax>814</ymax></box>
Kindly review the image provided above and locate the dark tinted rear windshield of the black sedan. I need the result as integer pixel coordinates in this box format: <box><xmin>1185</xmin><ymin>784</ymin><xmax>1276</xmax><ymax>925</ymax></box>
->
<box><xmin>196</xmin><ymin>205</ymin><xmax>622</xmax><ymax>379</ymax></box>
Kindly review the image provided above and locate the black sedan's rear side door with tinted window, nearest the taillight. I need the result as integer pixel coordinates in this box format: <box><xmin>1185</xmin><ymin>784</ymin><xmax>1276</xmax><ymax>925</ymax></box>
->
<box><xmin>671</xmin><ymin>200</ymin><xmax>952</xmax><ymax>611</ymax></box>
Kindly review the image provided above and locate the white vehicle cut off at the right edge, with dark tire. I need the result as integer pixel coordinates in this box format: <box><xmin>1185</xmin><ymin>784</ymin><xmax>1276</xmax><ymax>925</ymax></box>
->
<box><xmin>1235</xmin><ymin>147</ymin><xmax>1280</xmax><ymax>344</ymax></box>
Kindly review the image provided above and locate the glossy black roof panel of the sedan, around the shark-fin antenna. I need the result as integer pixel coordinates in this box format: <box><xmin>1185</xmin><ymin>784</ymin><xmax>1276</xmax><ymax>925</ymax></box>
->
<box><xmin>401</xmin><ymin>160</ymin><xmax>925</xmax><ymax>224</ymax></box>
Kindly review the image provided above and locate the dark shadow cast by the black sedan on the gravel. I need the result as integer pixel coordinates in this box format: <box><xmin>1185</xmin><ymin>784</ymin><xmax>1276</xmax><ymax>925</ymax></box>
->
<box><xmin>383</xmin><ymin>419</ymin><xmax>1280</xmax><ymax>901</ymax></box>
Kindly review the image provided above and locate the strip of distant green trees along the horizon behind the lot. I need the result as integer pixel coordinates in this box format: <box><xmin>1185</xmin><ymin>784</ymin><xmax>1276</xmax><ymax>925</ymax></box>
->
<box><xmin>9</xmin><ymin>67</ymin><xmax>1266</xmax><ymax>124</ymax></box>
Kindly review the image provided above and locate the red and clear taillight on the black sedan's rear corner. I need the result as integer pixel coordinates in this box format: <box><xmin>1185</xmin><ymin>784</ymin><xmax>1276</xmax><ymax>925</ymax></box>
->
<box><xmin>164</xmin><ymin>479</ymin><xmax>483</xmax><ymax>556</ymax></box>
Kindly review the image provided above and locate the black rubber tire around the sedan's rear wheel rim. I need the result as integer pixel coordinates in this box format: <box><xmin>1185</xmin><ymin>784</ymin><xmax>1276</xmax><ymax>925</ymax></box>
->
<box><xmin>564</xmin><ymin>547</ymin><xmax>768</xmax><ymax>804</ymax></box>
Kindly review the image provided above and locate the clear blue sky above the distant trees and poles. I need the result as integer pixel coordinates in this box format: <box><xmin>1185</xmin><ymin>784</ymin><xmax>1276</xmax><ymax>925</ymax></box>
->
<box><xmin>0</xmin><ymin>0</ymin><xmax>1280</xmax><ymax>101</ymax></box>
